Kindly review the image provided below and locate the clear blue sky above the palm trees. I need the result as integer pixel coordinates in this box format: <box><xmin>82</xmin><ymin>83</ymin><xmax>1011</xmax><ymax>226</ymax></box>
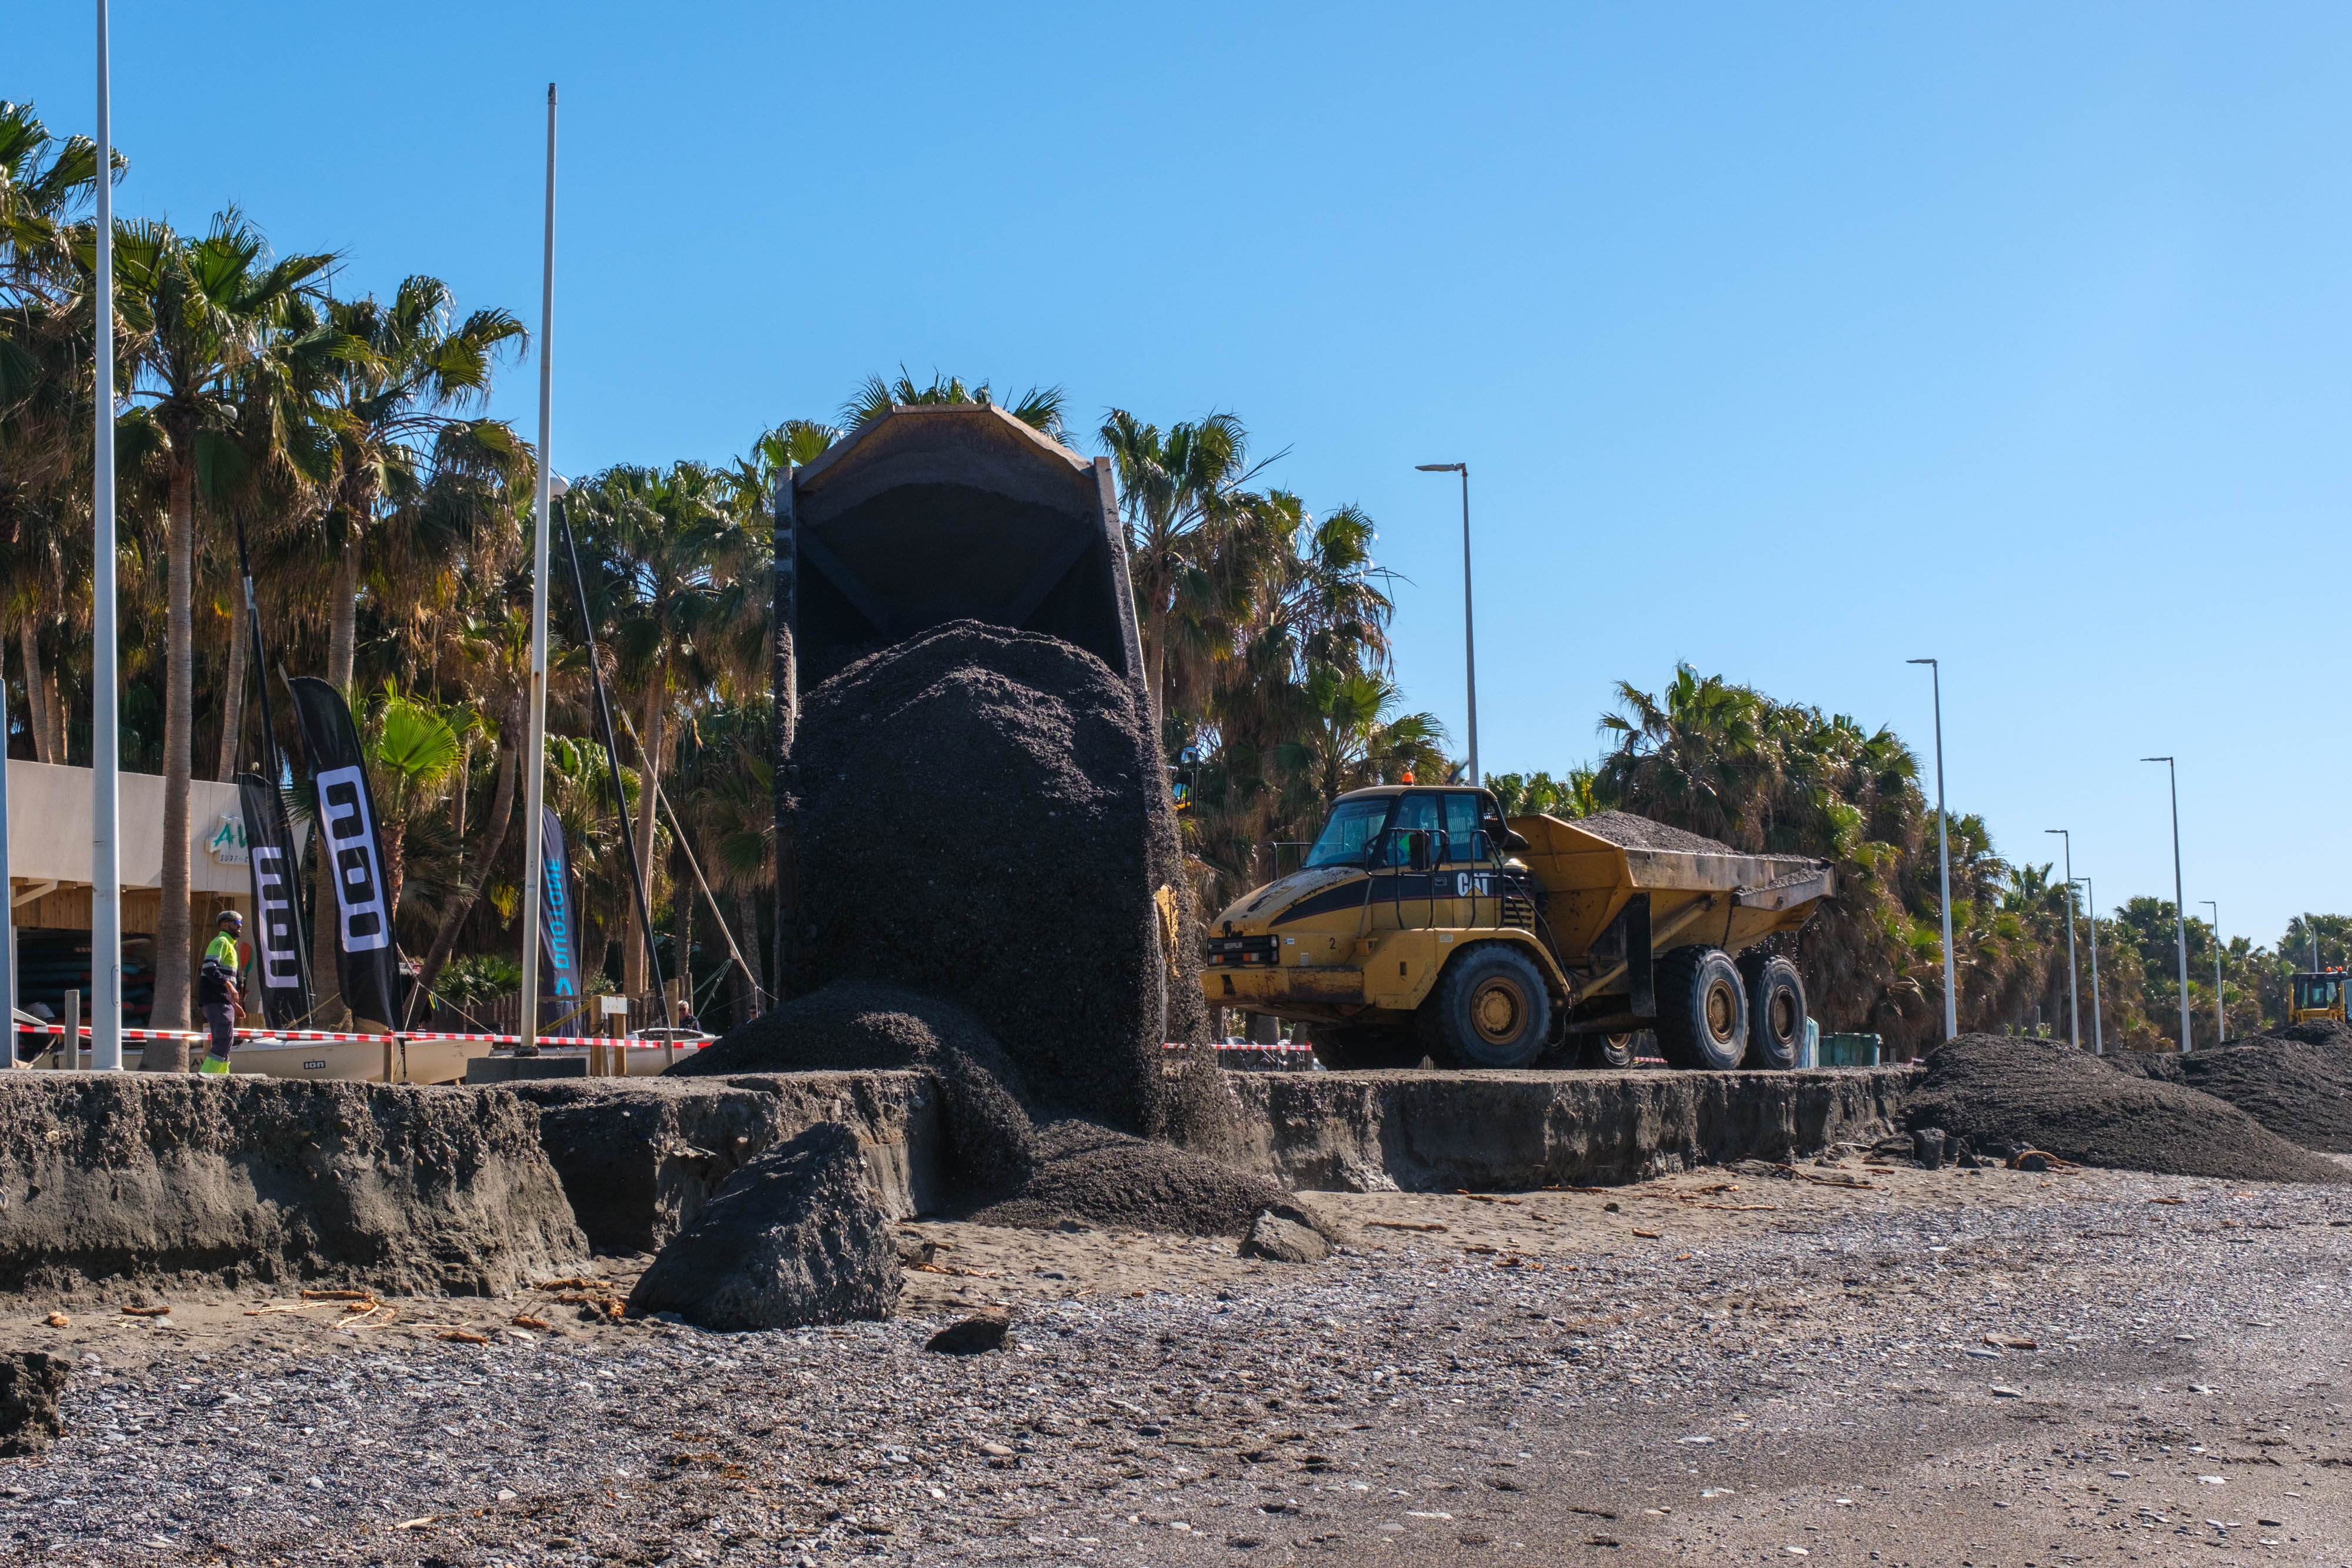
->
<box><xmin>18</xmin><ymin>0</ymin><xmax>2352</xmax><ymax>959</ymax></box>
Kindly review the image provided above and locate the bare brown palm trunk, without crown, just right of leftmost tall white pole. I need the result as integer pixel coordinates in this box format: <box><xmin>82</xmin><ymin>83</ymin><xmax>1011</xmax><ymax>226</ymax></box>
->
<box><xmin>143</xmin><ymin>453</ymin><xmax>195</xmax><ymax>1072</ymax></box>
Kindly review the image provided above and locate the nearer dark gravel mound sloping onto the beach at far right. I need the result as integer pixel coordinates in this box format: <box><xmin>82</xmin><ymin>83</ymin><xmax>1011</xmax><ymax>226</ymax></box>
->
<box><xmin>1903</xmin><ymin>1034</ymin><xmax>2345</xmax><ymax>1182</ymax></box>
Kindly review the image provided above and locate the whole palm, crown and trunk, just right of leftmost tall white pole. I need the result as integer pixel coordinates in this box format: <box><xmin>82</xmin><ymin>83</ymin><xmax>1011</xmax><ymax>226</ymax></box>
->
<box><xmin>115</xmin><ymin>209</ymin><xmax>334</xmax><ymax>1053</ymax></box>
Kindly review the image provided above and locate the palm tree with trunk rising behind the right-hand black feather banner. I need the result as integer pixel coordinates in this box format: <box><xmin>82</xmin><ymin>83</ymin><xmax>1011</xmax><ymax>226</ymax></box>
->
<box><xmin>327</xmin><ymin>275</ymin><xmax>527</xmax><ymax>689</ymax></box>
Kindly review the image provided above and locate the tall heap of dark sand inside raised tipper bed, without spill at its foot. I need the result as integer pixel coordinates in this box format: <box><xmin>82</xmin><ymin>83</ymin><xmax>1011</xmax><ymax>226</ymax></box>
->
<box><xmin>793</xmin><ymin>621</ymin><xmax>1204</xmax><ymax>1131</ymax></box>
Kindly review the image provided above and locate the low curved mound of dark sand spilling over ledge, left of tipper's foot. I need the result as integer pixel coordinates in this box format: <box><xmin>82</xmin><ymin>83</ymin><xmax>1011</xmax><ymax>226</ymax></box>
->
<box><xmin>663</xmin><ymin>982</ymin><xmax>1033</xmax><ymax>1199</ymax></box>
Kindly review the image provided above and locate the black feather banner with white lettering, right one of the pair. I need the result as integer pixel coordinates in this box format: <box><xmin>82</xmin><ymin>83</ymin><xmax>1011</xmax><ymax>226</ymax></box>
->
<box><xmin>287</xmin><ymin>675</ymin><xmax>400</xmax><ymax>1025</ymax></box>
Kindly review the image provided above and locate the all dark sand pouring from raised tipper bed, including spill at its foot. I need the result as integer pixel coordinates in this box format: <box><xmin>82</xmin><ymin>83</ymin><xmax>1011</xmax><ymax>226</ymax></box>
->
<box><xmin>673</xmin><ymin>623</ymin><xmax>1294</xmax><ymax>1234</ymax></box>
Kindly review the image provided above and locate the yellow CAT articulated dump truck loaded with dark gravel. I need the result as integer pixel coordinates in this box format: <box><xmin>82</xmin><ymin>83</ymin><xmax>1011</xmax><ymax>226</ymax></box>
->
<box><xmin>1202</xmin><ymin>785</ymin><xmax>1835</xmax><ymax>1067</ymax></box>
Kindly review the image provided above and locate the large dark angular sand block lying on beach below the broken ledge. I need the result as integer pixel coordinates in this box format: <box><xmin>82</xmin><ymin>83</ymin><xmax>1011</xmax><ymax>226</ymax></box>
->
<box><xmin>628</xmin><ymin>1121</ymin><xmax>903</xmax><ymax>1333</ymax></box>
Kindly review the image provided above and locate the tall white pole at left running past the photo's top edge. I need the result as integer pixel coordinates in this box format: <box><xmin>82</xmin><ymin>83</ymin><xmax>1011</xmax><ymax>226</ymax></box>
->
<box><xmin>89</xmin><ymin>0</ymin><xmax>122</xmax><ymax>1072</ymax></box>
